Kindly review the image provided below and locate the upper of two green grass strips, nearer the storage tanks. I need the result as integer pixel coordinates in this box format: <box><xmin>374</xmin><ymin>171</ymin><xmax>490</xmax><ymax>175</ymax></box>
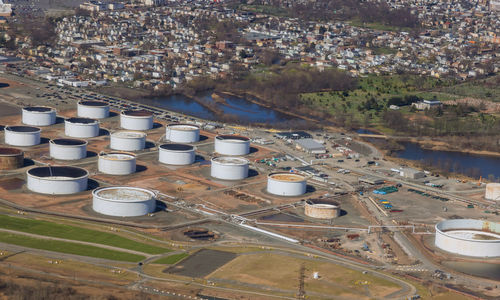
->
<box><xmin>0</xmin><ymin>215</ymin><xmax>170</xmax><ymax>254</ymax></box>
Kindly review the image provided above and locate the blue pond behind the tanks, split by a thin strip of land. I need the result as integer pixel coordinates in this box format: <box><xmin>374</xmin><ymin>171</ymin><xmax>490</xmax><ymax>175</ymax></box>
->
<box><xmin>141</xmin><ymin>93</ymin><xmax>296</xmax><ymax>124</ymax></box>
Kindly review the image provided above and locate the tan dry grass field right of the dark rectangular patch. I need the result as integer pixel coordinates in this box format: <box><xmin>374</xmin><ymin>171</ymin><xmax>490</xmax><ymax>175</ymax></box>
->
<box><xmin>209</xmin><ymin>252</ymin><xmax>398</xmax><ymax>299</ymax></box>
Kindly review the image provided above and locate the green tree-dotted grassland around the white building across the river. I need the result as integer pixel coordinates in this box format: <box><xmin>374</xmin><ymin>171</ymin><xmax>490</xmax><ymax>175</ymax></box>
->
<box><xmin>301</xmin><ymin>75</ymin><xmax>500</xmax><ymax>134</ymax></box>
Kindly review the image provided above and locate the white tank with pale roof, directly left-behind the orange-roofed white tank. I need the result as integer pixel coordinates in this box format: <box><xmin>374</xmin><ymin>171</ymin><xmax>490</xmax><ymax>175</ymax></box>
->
<box><xmin>210</xmin><ymin>157</ymin><xmax>249</xmax><ymax>180</ymax></box>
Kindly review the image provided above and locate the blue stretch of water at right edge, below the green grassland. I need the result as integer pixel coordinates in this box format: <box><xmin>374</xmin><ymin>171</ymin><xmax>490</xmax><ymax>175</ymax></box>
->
<box><xmin>394</xmin><ymin>142</ymin><xmax>500</xmax><ymax>178</ymax></box>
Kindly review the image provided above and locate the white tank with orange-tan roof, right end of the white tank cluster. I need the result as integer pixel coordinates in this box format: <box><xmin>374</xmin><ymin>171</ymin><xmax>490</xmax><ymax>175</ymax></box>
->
<box><xmin>267</xmin><ymin>172</ymin><xmax>307</xmax><ymax>196</ymax></box>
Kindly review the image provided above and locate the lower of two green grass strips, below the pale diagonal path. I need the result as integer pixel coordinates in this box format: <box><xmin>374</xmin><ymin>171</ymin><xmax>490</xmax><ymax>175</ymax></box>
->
<box><xmin>0</xmin><ymin>232</ymin><xmax>145</xmax><ymax>262</ymax></box>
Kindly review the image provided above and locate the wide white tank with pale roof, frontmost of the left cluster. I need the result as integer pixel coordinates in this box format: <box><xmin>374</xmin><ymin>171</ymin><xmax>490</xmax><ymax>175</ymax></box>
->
<box><xmin>92</xmin><ymin>186</ymin><xmax>156</xmax><ymax>217</ymax></box>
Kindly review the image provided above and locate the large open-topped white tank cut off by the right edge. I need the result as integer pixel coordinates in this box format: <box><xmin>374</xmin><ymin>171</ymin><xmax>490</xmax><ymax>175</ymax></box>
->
<box><xmin>434</xmin><ymin>219</ymin><xmax>500</xmax><ymax>257</ymax></box>
